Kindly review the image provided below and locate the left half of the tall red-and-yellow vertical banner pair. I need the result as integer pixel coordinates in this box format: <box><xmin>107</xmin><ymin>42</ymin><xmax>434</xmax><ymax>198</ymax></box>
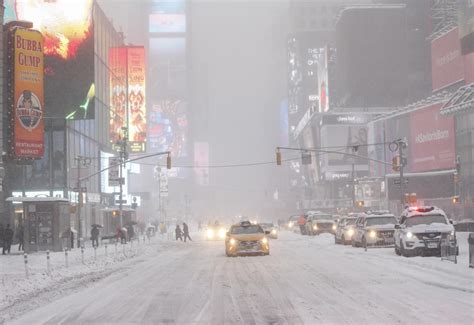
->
<box><xmin>109</xmin><ymin>47</ymin><xmax>127</xmax><ymax>144</ymax></box>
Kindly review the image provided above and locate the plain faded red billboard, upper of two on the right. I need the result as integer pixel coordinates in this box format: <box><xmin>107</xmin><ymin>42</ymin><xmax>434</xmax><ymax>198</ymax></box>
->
<box><xmin>431</xmin><ymin>28</ymin><xmax>464</xmax><ymax>91</ymax></box>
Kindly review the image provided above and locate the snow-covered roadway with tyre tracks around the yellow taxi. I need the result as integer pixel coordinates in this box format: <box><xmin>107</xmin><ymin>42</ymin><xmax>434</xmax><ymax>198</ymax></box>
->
<box><xmin>7</xmin><ymin>233</ymin><xmax>474</xmax><ymax>324</ymax></box>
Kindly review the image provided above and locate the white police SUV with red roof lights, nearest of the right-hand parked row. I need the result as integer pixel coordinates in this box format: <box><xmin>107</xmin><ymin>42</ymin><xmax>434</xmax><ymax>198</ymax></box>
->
<box><xmin>395</xmin><ymin>206</ymin><xmax>456</xmax><ymax>257</ymax></box>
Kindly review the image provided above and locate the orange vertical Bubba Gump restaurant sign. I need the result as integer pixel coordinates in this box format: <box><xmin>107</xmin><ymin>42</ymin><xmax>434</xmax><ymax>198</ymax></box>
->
<box><xmin>11</xmin><ymin>28</ymin><xmax>45</xmax><ymax>158</ymax></box>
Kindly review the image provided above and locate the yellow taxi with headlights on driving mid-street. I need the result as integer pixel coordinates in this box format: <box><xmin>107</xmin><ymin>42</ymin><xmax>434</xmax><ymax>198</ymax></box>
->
<box><xmin>225</xmin><ymin>221</ymin><xmax>270</xmax><ymax>256</ymax></box>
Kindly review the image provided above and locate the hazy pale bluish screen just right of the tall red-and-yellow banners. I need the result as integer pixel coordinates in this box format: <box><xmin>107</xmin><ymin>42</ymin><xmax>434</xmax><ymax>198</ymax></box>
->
<box><xmin>148</xmin><ymin>100</ymin><xmax>188</xmax><ymax>158</ymax></box>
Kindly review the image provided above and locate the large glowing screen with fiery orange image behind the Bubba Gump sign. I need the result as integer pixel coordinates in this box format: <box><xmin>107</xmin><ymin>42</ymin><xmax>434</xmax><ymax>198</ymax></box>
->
<box><xmin>14</xmin><ymin>0</ymin><xmax>95</xmax><ymax>119</ymax></box>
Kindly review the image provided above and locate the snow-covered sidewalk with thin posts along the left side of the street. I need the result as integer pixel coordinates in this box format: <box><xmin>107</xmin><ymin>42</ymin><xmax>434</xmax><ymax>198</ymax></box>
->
<box><xmin>0</xmin><ymin>235</ymin><xmax>172</xmax><ymax>324</ymax></box>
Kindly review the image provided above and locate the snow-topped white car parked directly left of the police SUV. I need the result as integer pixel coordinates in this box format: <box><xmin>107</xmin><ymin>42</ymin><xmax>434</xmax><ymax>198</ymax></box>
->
<box><xmin>352</xmin><ymin>213</ymin><xmax>398</xmax><ymax>247</ymax></box>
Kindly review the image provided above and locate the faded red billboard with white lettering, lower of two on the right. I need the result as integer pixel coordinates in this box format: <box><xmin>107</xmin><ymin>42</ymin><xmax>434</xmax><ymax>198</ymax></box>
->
<box><xmin>409</xmin><ymin>103</ymin><xmax>456</xmax><ymax>172</ymax></box>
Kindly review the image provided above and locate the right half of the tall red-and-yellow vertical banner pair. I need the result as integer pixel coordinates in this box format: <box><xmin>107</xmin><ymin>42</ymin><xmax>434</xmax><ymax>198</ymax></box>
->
<box><xmin>127</xmin><ymin>46</ymin><xmax>147</xmax><ymax>152</ymax></box>
